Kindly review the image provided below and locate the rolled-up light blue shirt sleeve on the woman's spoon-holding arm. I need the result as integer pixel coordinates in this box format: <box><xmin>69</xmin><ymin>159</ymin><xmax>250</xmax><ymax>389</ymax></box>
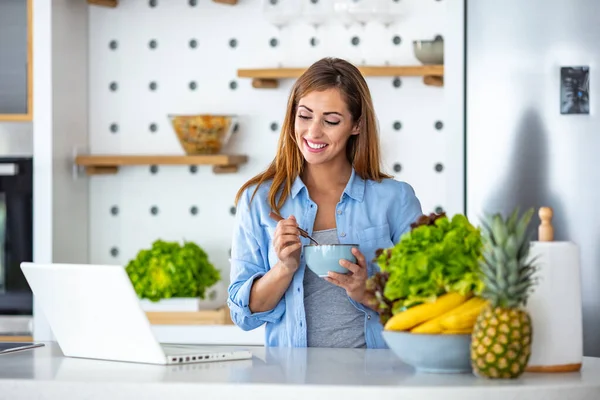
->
<box><xmin>227</xmin><ymin>190</ymin><xmax>285</xmax><ymax>331</ymax></box>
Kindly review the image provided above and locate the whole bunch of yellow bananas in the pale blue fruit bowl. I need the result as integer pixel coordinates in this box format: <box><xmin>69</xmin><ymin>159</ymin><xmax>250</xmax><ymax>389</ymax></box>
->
<box><xmin>384</xmin><ymin>293</ymin><xmax>487</xmax><ymax>334</ymax></box>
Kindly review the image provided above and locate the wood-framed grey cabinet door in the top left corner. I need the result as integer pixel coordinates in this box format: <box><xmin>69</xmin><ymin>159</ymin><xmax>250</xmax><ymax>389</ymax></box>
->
<box><xmin>0</xmin><ymin>0</ymin><xmax>33</xmax><ymax>121</ymax></box>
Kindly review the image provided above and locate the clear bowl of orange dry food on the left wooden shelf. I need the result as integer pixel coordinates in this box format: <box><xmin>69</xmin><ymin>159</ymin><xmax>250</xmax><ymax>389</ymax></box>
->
<box><xmin>168</xmin><ymin>114</ymin><xmax>238</xmax><ymax>155</ymax></box>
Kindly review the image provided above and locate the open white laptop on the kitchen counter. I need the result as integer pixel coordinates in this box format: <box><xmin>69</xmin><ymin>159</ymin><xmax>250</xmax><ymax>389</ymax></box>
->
<box><xmin>21</xmin><ymin>262</ymin><xmax>252</xmax><ymax>364</ymax></box>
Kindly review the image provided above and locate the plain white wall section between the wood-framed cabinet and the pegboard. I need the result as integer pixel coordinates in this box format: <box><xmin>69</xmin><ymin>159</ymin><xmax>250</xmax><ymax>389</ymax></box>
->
<box><xmin>33</xmin><ymin>0</ymin><xmax>89</xmax><ymax>340</ymax></box>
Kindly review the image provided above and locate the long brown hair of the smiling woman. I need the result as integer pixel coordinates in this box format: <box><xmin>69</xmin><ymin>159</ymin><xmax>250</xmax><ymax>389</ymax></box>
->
<box><xmin>235</xmin><ymin>57</ymin><xmax>391</xmax><ymax>212</ymax></box>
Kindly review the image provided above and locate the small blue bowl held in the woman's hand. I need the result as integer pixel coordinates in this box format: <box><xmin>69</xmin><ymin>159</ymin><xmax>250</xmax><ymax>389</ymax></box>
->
<box><xmin>304</xmin><ymin>244</ymin><xmax>358</xmax><ymax>278</ymax></box>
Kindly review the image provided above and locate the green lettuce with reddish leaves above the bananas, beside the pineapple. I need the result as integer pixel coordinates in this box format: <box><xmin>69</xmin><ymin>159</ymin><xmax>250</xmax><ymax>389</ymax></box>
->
<box><xmin>367</xmin><ymin>213</ymin><xmax>483</xmax><ymax>324</ymax></box>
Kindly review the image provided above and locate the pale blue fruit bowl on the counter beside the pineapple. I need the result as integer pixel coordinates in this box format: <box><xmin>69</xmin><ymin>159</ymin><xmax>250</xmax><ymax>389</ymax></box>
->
<box><xmin>383</xmin><ymin>330</ymin><xmax>472</xmax><ymax>374</ymax></box>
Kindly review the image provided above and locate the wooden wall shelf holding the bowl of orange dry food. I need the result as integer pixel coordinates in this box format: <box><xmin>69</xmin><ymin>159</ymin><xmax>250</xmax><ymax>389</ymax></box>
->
<box><xmin>75</xmin><ymin>154</ymin><xmax>248</xmax><ymax>175</ymax></box>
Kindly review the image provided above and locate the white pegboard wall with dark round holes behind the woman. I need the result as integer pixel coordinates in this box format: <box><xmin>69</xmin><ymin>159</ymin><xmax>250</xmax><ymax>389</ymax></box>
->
<box><xmin>89</xmin><ymin>0</ymin><xmax>456</xmax><ymax>306</ymax></box>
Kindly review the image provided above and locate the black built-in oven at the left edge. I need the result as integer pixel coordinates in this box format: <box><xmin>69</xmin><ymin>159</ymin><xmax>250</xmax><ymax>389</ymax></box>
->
<box><xmin>0</xmin><ymin>157</ymin><xmax>33</xmax><ymax>315</ymax></box>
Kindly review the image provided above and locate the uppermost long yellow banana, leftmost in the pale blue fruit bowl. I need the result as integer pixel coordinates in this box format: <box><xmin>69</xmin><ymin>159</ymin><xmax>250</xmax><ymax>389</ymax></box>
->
<box><xmin>384</xmin><ymin>293</ymin><xmax>469</xmax><ymax>331</ymax></box>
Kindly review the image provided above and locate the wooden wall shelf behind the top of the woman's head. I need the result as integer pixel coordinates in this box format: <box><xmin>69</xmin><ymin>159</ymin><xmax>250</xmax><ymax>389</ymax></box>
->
<box><xmin>238</xmin><ymin>65</ymin><xmax>444</xmax><ymax>89</ymax></box>
